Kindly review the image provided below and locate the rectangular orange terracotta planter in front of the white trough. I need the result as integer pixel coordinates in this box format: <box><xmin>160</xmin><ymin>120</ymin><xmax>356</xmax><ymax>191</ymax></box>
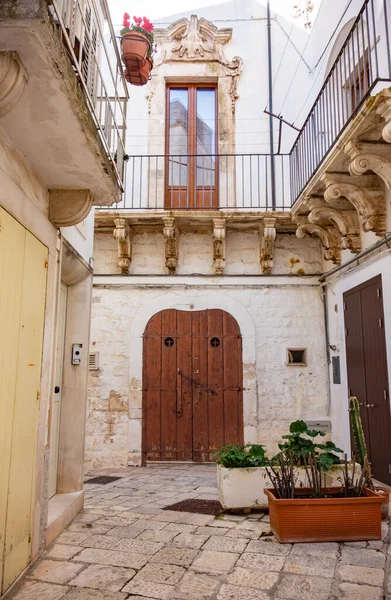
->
<box><xmin>265</xmin><ymin>487</ymin><xmax>384</xmax><ymax>544</ymax></box>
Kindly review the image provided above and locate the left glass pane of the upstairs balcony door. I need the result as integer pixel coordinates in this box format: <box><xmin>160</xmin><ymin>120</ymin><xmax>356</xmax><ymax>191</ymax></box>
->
<box><xmin>168</xmin><ymin>88</ymin><xmax>189</xmax><ymax>186</ymax></box>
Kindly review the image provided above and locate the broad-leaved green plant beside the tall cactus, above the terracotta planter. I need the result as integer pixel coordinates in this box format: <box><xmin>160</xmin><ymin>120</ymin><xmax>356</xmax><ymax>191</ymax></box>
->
<box><xmin>275</xmin><ymin>420</ymin><xmax>343</xmax><ymax>471</ymax></box>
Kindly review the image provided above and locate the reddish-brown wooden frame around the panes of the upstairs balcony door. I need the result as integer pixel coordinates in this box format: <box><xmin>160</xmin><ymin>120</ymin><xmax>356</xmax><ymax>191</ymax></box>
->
<box><xmin>164</xmin><ymin>82</ymin><xmax>219</xmax><ymax>210</ymax></box>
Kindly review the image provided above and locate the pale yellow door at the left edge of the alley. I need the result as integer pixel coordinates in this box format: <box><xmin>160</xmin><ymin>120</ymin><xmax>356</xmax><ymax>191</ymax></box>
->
<box><xmin>0</xmin><ymin>210</ymin><xmax>47</xmax><ymax>591</ymax></box>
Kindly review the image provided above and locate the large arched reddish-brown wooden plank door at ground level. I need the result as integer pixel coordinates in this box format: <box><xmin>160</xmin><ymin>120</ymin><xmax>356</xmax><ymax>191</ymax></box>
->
<box><xmin>143</xmin><ymin>310</ymin><xmax>243</xmax><ymax>462</ymax></box>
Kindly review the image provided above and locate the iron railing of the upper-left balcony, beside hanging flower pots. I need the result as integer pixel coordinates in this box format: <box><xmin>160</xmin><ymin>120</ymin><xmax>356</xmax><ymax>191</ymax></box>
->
<box><xmin>50</xmin><ymin>0</ymin><xmax>129</xmax><ymax>190</ymax></box>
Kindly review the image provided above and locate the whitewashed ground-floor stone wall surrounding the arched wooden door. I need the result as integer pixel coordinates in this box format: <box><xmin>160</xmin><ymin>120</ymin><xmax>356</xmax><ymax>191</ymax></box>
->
<box><xmin>86</xmin><ymin>276</ymin><xmax>328</xmax><ymax>468</ymax></box>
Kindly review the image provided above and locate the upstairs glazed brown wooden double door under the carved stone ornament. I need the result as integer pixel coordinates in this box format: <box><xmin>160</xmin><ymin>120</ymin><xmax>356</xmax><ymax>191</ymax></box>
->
<box><xmin>165</xmin><ymin>83</ymin><xmax>218</xmax><ymax>210</ymax></box>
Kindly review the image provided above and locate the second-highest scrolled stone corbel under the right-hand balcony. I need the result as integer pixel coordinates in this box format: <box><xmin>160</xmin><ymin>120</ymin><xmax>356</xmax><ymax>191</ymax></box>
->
<box><xmin>344</xmin><ymin>140</ymin><xmax>391</xmax><ymax>190</ymax></box>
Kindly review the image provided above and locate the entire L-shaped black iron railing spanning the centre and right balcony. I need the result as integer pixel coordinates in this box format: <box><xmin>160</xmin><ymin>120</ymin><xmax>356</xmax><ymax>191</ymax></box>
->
<box><xmin>94</xmin><ymin>0</ymin><xmax>391</xmax><ymax>218</ymax></box>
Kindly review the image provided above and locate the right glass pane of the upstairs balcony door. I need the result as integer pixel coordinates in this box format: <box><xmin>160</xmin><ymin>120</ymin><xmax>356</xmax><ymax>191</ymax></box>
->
<box><xmin>196</xmin><ymin>88</ymin><xmax>216</xmax><ymax>186</ymax></box>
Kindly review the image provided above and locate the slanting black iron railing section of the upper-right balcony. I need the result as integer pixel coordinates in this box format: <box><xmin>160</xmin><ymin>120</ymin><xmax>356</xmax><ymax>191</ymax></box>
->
<box><xmin>290</xmin><ymin>0</ymin><xmax>391</xmax><ymax>204</ymax></box>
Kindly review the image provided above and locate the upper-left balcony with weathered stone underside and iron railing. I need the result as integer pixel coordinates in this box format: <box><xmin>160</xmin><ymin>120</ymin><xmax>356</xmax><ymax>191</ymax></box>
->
<box><xmin>0</xmin><ymin>0</ymin><xmax>128</xmax><ymax>205</ymax></box>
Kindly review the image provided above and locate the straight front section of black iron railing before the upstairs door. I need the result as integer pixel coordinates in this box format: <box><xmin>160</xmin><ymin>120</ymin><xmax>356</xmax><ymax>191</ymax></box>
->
<box><xmin>110</xmin><ymin>154</ymin><xmax>291</xmax><ymax>211</ymax></box>
